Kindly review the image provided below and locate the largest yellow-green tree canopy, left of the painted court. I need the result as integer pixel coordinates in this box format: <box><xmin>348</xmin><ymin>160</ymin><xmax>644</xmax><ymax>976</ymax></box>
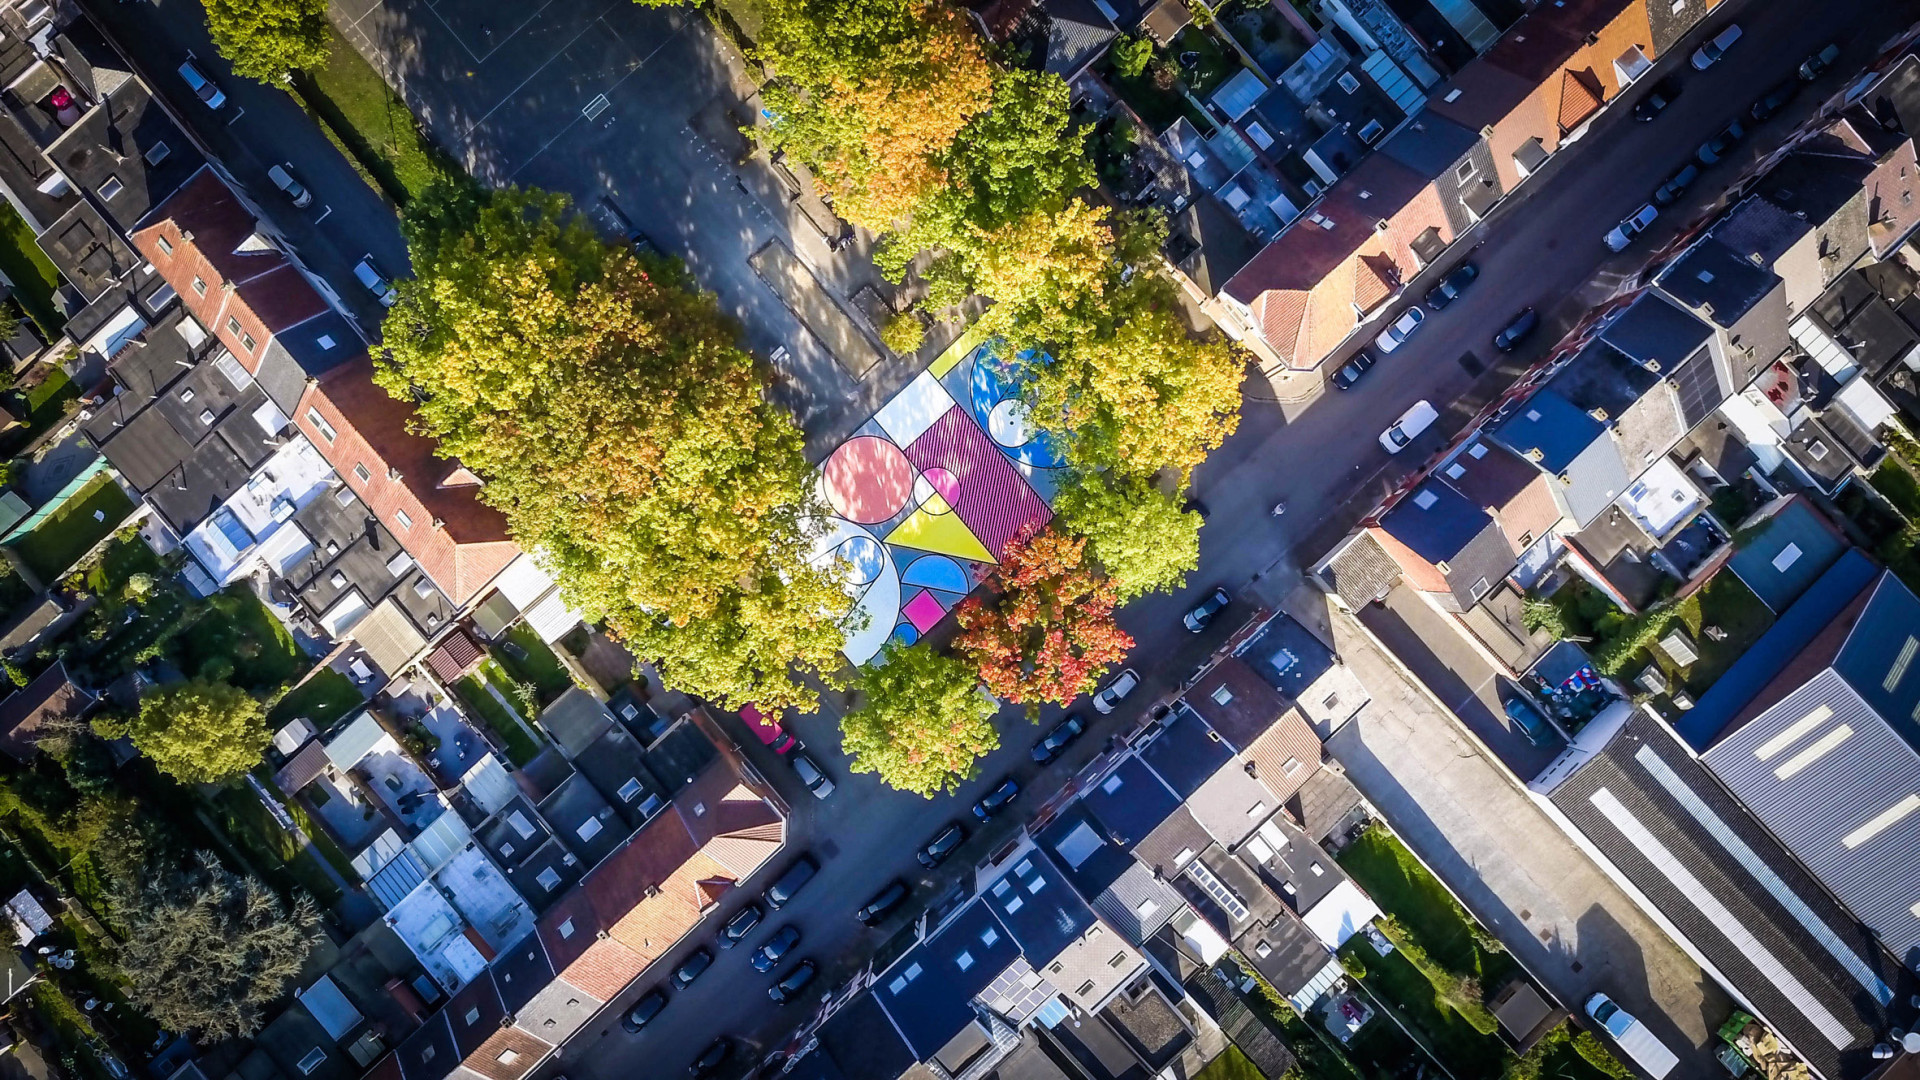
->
<box><xmin>376</xmin><ymin>188</ymin><xmax>849</xmax><ymax>709</ymax></box>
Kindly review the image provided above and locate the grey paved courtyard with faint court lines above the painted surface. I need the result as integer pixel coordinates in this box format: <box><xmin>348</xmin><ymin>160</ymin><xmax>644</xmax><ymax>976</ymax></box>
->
<box><xmin>332</xmin><ymin>0</ymin><xmax>956</xmax><ymax>459</ymax></box>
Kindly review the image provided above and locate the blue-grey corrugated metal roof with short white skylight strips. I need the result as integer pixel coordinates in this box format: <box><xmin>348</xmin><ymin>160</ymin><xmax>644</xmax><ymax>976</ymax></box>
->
<box><xmin>1701</xmin><ymin>669</ymin><xmax>1920</xmax><ymax>972</ymax></box>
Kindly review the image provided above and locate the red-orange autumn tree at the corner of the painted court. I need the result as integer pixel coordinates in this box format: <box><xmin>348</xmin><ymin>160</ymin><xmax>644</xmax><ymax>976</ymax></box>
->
<box><xmin>954</xmin><ymin>530</ymin><xmax>1133</xmax><ymax>717</ymax></box>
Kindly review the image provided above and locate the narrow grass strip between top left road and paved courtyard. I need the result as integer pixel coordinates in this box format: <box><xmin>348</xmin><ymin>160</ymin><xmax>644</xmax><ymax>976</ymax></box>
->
<box><xmin>294</xmin><ymin>27</ymin><xmax>468</xmax><ymax>208</ymax></box>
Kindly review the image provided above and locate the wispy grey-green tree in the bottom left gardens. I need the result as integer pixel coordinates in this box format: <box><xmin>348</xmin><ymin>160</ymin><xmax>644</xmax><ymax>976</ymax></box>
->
<box><xmin>111</xmin><ymin>851</ymin><xmax>321</xmax><ymax>1045</ymax></box>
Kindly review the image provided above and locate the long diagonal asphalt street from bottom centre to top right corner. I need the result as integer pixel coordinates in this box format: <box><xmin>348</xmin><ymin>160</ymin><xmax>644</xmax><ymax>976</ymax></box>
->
<box><xmin>555</xmin><ymin>0</ymin><xmax>1916</xmax><ymax>1080</ymax></box>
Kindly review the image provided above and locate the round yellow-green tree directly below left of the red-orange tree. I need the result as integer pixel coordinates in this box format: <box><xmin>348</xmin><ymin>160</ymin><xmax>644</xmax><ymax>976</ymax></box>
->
<box><xmin>841</xmin><ymin>642</ymin><xmax>1000</xmax><ymax>798</ymax></box>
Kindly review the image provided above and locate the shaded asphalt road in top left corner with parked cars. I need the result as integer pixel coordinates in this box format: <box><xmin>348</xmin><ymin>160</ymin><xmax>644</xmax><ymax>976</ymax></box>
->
<box><xmin>84</xmin><ymin>0</ymin><xmax>409</xmax><ymax>338</ymax></box>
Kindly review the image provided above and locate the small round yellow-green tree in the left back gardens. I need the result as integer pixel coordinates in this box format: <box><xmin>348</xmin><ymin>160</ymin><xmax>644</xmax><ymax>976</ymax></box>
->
<box><xmin>94</xmin><ymin>678</ymin><xmax>273</xmax><ymax>784</ymax></box>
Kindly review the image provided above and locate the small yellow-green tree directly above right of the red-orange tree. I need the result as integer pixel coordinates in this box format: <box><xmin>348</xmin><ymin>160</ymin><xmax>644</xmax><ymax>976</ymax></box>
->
<box><xmin>1054</xmin><ymin>473</ymin><xmax>1200</xmax><ymax>603</ymax></box>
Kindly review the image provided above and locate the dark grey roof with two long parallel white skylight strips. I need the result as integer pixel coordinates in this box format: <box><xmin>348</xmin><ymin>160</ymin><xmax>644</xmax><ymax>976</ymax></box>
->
<box><xmin>1549</xmin><ymin>713</ymin><xmax>1910</xmax><ymax>1080</ymax></box>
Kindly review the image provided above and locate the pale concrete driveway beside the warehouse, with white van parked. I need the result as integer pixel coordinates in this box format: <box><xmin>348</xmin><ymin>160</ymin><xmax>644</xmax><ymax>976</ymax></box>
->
<box><xmin>1294</xmin><ymin>588</ymin><xmax>1734</xmax><ymax>1076</ymax></box>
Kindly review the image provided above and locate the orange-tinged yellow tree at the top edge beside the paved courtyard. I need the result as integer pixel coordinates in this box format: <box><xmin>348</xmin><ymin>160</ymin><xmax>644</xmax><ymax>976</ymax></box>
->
<box><xmin>756</xmin><ymin>0</ymin><xmax>993</xmax><ymax>233</ymax></box>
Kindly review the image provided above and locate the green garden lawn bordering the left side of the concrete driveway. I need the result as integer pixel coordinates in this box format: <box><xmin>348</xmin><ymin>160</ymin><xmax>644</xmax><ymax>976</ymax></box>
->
<box><xmin>1338</xmin><ymin>824</ymin><xmax>1515</xmax><ymax>990</ymax></box>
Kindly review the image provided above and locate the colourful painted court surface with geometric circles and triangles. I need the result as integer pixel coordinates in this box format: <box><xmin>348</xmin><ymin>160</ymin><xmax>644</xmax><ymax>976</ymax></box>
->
<box><xmin>814</xmin><ymin>336</ymin><xmax>1062</xmax><ymax>665</ymax></box>
